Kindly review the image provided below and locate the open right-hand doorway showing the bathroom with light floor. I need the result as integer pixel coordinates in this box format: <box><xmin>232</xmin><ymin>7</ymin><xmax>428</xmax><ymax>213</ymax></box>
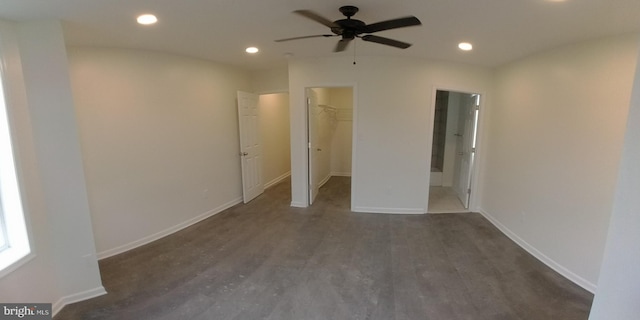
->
<box><xmin>427</xmin><ymin>90</ymin><xmax>480</xmax><ymax>213</ymax></box>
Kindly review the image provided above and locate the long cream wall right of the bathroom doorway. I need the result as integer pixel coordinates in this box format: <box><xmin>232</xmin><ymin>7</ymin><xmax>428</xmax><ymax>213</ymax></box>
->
<box><xmin>481</xmin><ymin>35</ymin><xmax>638</xmax><ymax>290</ymax></box>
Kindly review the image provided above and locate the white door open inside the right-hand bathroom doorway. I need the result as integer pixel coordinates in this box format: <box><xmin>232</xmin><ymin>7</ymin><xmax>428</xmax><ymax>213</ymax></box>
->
<box><xmin>453</xmin><ymin>94</ymin><xmax>480</xmax><ymax>208</ymax></box>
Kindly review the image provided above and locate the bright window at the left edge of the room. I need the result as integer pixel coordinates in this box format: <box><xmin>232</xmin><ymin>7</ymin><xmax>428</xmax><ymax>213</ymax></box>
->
<box><xmin>0</xmin><ymin>63</ymin><xmax>31</xmax><ymax>277</ymax></box>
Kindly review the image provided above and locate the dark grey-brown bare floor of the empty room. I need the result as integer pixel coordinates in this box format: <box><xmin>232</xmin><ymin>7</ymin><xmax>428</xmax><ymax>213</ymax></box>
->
<box><xmin>55</xmin><ymin>177</ymin><xmax>593</xmax><ymax>320</ymax></box>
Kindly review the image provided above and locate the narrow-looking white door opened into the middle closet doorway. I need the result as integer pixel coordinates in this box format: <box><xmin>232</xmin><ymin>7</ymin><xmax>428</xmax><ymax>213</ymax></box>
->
<box><xmin>307</xmin><ymin>89</ymin><xmax>322</xmax><ymax>205</ymax></box>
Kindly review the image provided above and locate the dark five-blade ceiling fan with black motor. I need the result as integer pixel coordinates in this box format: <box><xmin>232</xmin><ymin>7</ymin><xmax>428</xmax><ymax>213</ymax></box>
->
<box><xmin>276</xmin><ymin>6</ymin><xmax>422</xmax><ymax>52</ymax></box>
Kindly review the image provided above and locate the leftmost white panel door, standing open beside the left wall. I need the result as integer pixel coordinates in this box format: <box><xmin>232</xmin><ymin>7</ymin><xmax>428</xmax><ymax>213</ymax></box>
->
<box><xmin>238</xmin><ymin>91</ymin><xmax>264</xmax><ymax>203</ymax></box>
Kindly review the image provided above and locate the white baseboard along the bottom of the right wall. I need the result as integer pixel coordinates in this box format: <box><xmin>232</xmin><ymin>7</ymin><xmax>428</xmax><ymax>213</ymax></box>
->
<box><xmin>479</xmin><ymin>209</ymin><xmax>597</xmax><ymax>293</ymax></box>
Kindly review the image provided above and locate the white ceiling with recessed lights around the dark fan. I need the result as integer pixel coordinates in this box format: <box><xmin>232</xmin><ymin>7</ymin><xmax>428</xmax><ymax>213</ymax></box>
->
<box><xmin>0</xmin><ymin>0</ymin><xmax>640</xmax><ymax>69</ymax></box>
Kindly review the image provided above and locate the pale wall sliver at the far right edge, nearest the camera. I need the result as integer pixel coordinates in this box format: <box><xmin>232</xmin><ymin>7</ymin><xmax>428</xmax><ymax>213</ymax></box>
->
<box><xmin>589</xmin><ymin>36</ymin><xmax>640</xmax><ymax>320</ymax></box>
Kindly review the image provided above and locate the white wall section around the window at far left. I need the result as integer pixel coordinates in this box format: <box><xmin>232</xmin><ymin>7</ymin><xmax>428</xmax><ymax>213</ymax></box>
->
<box><xmin>0</xmin><ymin>21</ymin><xmax>105</xmax><ymax>313</ymax></box>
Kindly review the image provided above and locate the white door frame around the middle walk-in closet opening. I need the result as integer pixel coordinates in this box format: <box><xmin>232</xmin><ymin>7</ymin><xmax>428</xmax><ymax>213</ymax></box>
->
<box><xmin>304</xmin><ymin>83</ymin><xmax>358</xmax><ymax>211</ymax></box>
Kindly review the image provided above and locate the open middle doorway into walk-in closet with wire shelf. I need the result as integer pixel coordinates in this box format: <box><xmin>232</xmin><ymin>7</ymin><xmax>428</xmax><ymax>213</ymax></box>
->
<box><xmin>306</xmin><ymin>87</ymin><xmax>353</xmax><ymax>205</ymax></box>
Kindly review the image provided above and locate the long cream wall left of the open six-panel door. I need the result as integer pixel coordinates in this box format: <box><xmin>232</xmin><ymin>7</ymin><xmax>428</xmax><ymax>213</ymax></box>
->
<box><xmin>69</xmin><ymin>48</ymin><xmax>250</xmax><ymax>257</ymax></box>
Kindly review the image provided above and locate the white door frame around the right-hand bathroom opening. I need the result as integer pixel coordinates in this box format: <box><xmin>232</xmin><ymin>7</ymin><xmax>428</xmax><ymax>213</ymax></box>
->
<box><xmin>425</xmin><ymin>85</ymin><xmax>488</xmax><ymax>212</ymax></box>
